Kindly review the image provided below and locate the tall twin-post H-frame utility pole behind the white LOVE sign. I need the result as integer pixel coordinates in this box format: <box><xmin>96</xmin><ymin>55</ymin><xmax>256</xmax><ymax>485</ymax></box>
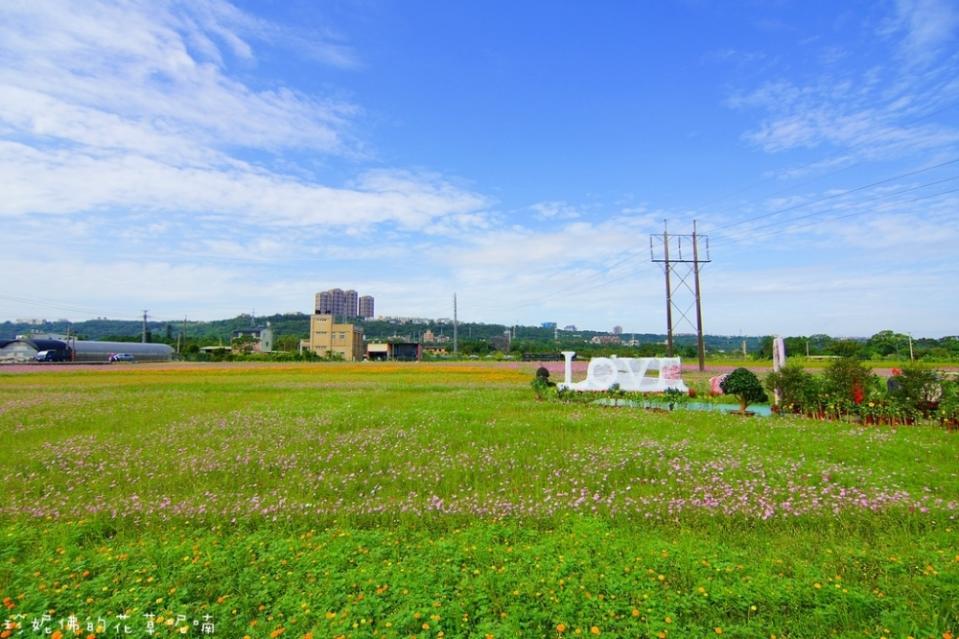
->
<box><xmin>649</xmin><ymin>220</ymin><xmax>712</xmax><ymax>371</ymax></box>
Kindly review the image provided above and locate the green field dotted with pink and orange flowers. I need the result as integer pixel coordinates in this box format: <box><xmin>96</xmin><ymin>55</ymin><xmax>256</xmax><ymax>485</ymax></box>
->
<box><xmin>0</xmin><ymin>364</ymin><xmax>959</xmax><ymax>639</ymax></box>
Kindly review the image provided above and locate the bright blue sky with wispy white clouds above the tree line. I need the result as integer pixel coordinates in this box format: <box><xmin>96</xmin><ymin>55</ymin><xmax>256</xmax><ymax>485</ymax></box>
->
<box><xmin>0</xmin><ymin>0</ymin><xmax>959</xmax><ymax>336</ymax></box>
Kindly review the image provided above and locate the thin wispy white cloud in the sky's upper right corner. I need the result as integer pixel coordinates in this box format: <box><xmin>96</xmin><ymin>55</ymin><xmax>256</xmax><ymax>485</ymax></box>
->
<box><xmin>727</xmin><ymin>0</ymin><xmax>959</xmax><ymax>165</ymax></box>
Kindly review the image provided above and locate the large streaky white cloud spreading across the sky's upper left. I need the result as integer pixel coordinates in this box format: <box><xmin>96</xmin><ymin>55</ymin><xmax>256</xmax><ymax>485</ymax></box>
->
<box><xmin>0</xmin><ymin>0</ymin><xmax>487</xmax><ymax>232</ymax></box>
